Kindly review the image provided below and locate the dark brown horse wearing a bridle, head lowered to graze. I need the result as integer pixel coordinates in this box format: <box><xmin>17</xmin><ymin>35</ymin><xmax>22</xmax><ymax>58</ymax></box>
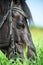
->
<box><xmin>0</xmin><ymin>0</ymin><xmax>37</xmax><ymax>59</ymax></box>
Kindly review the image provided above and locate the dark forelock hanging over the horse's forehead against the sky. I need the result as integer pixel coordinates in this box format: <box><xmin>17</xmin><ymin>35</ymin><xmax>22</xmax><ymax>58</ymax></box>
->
<box><xmin>20</xmin><ymin>0</ymin><xmax>32</xmax><ymax>20</ymax></box>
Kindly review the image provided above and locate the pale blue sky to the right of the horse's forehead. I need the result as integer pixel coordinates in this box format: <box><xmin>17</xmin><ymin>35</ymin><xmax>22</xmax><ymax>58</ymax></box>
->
<box><xmin>26</xmin><ymin>0</ymin><xmax>43</xmax><ymax>28</ymax></box>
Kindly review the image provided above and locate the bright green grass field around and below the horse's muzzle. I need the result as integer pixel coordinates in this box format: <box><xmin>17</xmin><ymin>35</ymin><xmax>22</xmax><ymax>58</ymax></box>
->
<box><xmin>0</xmin><ymin>27</ymin><xmax>43</xmax><ymax>65</ymax></box>
